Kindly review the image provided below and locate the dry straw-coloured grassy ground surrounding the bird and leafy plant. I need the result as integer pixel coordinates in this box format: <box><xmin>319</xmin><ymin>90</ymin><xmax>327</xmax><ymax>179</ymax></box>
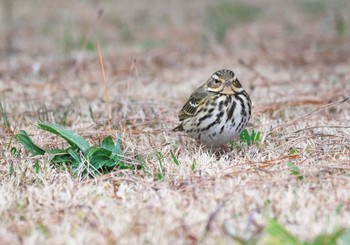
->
<box><xmin>0</xmin><ymin>0</ymin><xmax>350</xmax><ymax>244</ymax></box>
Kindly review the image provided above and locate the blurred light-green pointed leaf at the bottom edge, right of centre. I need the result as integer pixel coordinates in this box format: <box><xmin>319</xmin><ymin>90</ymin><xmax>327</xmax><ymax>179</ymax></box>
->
<box><xmin>265</xmin><ymin>219</ymin><xmax>301</xmax><ymax>245</ymax></box>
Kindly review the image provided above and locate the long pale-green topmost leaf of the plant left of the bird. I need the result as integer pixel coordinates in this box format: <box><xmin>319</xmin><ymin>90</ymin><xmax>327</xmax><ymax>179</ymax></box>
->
<box><xmin>38</xmin><ymin>123</ymin><xmax>90</xmax><ymax>153</ymax></box>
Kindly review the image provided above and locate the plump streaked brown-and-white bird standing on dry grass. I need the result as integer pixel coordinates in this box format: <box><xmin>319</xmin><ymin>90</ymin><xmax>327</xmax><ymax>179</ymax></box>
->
<box><xmin>173</xmin><ymin>69</ymin><xmax>252</xmax><ymax>148</ymax></box>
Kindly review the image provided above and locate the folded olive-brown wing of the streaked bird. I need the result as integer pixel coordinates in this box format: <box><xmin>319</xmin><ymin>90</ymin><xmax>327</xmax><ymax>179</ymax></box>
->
<box><xmin>179</xmin><ymin>90</ymin><xmax>210</xmax><ymax>121</ymax></box>
